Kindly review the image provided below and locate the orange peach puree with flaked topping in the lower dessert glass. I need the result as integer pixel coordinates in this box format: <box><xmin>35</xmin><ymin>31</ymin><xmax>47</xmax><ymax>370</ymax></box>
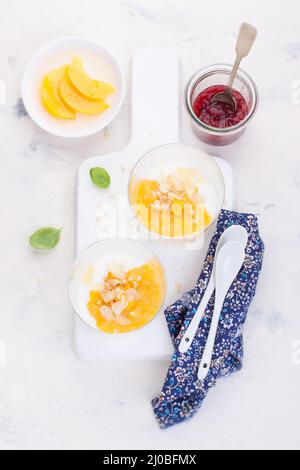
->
<box><xmin>87</xmin><ymin>259</ymin><xmax>165</xmax><ymax>334</ymax></box>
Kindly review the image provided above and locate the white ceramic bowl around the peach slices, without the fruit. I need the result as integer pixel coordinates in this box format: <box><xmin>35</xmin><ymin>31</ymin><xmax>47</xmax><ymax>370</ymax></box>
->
<box><xmin>22</xmin><ymin>37</ymin><xmax>125</xmax><ymax>138</ymax></box>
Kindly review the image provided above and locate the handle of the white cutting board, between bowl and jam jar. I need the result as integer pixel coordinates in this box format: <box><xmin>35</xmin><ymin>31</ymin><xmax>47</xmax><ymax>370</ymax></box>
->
<box><xmin>131</xmin><ymin>48</ymin><xmax>180</xmax><ymax>149</ymax></box>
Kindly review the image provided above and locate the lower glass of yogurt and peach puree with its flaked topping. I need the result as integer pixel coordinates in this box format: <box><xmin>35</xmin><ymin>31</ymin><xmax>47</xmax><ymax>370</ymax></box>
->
<box><xmin>69</xmin><ymin>239</ymin><xmax>166</xmax><ymax>335</ymax></box>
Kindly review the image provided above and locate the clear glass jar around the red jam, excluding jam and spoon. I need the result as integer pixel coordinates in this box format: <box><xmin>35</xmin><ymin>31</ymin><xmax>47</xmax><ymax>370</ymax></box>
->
<box><xmin>184</xmin><ymin>64</ymin><xmax>259</xmax><ymax>146</ymax></box>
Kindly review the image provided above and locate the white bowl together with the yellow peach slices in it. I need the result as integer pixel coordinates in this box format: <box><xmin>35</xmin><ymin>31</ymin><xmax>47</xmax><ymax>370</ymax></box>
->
<box><xmin>22</xmin><ymin>37</ymin><xmax>125</xmax><ymax>138</ymax></box>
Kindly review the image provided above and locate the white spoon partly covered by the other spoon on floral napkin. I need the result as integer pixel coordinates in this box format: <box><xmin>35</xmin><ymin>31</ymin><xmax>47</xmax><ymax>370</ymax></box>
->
<box><xmin>179</xmin><ymin>225</ymin><xmax>248</xmax><ymax>353</ymax></box>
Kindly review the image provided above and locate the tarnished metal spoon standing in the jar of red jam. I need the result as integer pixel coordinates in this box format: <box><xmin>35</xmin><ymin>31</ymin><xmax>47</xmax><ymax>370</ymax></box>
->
<box><xmin>212</xmin><ymin>23</ymin><xmax>257</xmax><ymax>111</ymax></box>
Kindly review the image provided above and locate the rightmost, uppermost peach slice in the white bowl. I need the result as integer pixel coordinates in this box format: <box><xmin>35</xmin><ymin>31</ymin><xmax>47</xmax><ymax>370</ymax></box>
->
<box><xmin>68</xmin><ymin>57</ymin><xmax>115</xmax><ymax>100</ymax></box>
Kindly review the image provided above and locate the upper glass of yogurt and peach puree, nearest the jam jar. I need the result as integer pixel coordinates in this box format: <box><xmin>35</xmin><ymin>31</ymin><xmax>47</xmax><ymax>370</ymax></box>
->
<box><xmin>128</xmin><ymin>144</ymin><xmax>225</xmax><ymax>240</ymax></box>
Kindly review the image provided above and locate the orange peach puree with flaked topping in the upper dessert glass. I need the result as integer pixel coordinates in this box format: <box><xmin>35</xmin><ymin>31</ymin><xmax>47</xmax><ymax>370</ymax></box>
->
<box><xmin>130</xmin><ymin>168</ymin><xmax>211</xmax><ymax>238</ymax></box>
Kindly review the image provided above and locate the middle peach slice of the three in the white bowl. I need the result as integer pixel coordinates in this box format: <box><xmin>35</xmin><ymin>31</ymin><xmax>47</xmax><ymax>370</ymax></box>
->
<box><xmin>59</xmin><ymin>68</ymin><xmax>109</xmax><ymax>114</ymax></box>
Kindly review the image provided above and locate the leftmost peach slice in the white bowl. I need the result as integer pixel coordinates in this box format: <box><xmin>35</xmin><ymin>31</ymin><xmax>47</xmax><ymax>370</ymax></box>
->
<box><xmin>41</xmin><ymin>66</ymin><xmax>76</xmax><ymax>119</ymax></box>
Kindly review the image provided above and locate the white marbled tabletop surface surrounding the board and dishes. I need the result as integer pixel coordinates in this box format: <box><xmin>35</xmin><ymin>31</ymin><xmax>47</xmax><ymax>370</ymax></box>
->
<box><xmin>0</xmin><ymin>0</ymin><xmax>300</xmax><ymax>449</ymax></box>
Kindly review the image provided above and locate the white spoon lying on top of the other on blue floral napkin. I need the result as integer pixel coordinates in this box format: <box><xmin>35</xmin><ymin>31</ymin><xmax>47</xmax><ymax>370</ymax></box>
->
<box><xmin>198</xmin><ymin>242</ymin><xmax>245</xmax><ymax>380</ymax></box>
